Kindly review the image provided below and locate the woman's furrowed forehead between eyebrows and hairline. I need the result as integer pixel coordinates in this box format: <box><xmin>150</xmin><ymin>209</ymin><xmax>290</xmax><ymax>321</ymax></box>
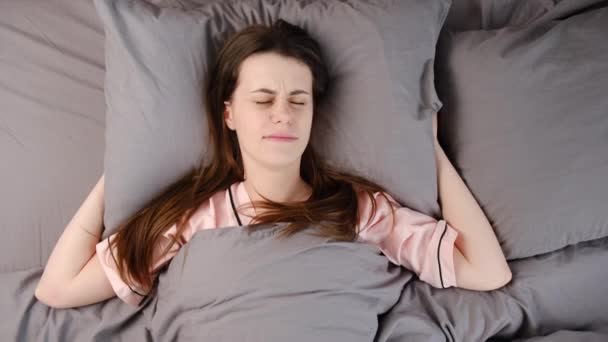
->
<box><xmin>238</xmin><ymin>52</ymin><xmax>312</xmax><ymax>90</ymax></box>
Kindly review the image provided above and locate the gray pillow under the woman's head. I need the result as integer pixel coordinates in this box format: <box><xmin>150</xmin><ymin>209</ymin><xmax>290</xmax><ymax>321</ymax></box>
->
<box><xmin>95</xmin><ymin>0</ymin><xmax>450</xmax><ymax>237</ymax></box>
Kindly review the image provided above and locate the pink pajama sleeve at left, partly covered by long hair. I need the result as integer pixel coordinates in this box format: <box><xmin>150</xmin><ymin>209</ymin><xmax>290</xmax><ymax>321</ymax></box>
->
<box><xmin>95</xmin><ymin>220</ymin><xmax>192</xmax><ymax>306</ymax></box>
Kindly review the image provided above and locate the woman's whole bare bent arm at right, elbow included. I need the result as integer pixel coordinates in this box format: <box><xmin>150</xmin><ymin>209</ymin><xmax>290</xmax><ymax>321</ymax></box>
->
<box><xmin>434</xmin><ymin>113</ymin><xmax>511</xmax><ymax>291</ymax></box>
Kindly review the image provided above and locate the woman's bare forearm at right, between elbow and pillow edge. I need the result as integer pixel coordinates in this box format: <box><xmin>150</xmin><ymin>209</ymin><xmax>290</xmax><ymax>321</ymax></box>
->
<box><xmin>435</xmin><ymin>141</ymin><xmax>508</xmax><ymax>272</ymax></box>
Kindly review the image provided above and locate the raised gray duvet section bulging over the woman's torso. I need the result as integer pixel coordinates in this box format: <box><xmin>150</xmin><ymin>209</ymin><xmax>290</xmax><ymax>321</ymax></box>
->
<box><xmin>144</xmin><ymin>225</ymin><xmax>412</xmax><ymax>342</ymax></box>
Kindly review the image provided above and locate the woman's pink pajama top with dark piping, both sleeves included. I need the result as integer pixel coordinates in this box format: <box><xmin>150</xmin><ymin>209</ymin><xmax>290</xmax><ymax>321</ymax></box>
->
<box><xmin>96</xmin><ymin>182</ymin><xmax>458</xmax><ymax>306</ymax></box>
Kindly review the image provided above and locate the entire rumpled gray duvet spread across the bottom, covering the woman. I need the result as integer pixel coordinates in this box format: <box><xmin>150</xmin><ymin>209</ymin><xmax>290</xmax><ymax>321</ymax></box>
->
<box><xmin>0</xmin><ymin>225</ymin><xmax>608</xmax><ymax>341</ymax></box>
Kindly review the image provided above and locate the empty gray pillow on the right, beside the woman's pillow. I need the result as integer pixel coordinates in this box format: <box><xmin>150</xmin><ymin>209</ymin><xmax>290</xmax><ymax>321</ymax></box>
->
<box><xmin>436</xmin><ymin>4</ymin><xmax>608</xmax><ymax>259</ymax></box>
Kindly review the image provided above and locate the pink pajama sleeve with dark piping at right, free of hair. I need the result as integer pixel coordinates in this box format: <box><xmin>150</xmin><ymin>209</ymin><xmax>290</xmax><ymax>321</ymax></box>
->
<box><xmin>359</xmin><ymin>192</ymin><xmax>458</xmax><ymax>288</ymax></box>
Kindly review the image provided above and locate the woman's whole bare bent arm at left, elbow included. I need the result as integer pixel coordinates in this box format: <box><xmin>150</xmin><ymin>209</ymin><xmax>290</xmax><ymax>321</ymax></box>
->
<box><xmin>35</xmin><ymin>175</ymin><xmax>116</xmax><ymax>308</ymax></box>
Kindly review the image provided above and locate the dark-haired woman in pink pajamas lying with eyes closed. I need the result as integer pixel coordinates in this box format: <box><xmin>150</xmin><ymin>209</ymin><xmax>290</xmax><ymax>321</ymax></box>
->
<box><xmin>36</xmin><ymin>20</ymin><xmax>511</xmax><ymax>308</ymax></box>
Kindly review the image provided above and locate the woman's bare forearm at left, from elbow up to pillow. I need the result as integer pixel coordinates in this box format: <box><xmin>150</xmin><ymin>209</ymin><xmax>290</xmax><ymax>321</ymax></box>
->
<box><xmin>38</xmin><ymin>176</ymin><xmax>104</xmax><ymax>290</ymax></box>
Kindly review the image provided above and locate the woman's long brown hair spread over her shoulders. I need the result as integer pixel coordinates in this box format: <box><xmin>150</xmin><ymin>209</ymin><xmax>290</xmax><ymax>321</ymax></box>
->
<box><xmin>110</xmin><ymin>19</ymin><xmax>396</xmax><ymax>304</ymax></box>
